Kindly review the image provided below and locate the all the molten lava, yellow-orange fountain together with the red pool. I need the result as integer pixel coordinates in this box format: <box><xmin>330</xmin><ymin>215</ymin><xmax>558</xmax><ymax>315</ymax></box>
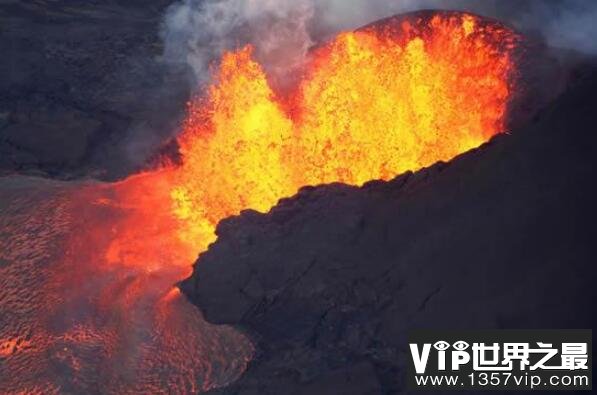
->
<box><xmin>0</xmin><ymin>12</ymin><xmax>519</xmax><ymax>394</ymax></box>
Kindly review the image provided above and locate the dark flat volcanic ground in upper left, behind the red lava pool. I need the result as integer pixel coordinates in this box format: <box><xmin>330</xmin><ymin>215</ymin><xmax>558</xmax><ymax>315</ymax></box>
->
<box><xmin>0</xmin><ymin>0</ymin><xmax>190</xmax><ymax>179</ymax></box>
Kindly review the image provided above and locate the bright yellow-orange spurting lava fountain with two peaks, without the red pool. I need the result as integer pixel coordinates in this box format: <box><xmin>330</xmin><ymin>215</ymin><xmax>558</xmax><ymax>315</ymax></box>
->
<box><xmin>172</xmin><ymin>13</ymin><xmax>517</xmax><ymax>254</ymax></box>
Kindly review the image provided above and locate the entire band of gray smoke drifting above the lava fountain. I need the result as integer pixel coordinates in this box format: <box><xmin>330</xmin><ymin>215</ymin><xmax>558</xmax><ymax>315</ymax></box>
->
<box><xmin>162</xmin><ymin>0</ymin><xmax>597</xmax><ymax>89</ymax></box>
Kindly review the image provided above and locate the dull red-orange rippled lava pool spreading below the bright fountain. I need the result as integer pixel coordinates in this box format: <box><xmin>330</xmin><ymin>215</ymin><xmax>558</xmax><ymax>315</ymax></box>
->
<box><xmin>0</xmin><ymin>177</ymin><xmax>253</xmax><ymax>394</ymax></box>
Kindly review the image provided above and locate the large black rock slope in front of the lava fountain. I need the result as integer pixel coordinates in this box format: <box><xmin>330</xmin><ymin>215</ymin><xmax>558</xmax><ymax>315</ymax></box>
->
<box><xmin>181</xmin><ymin>68</ymin><xmax>597</xmax><ymax>394</ymax></box>
